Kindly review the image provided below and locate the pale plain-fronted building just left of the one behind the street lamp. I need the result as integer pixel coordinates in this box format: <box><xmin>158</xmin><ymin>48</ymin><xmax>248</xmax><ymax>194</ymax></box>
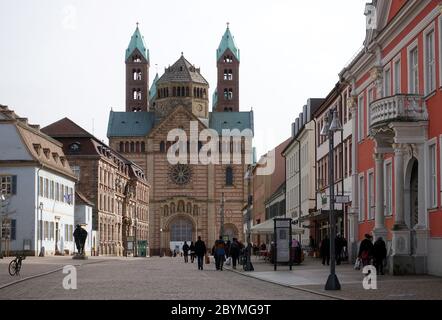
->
<box><xmin>283</xmin><ymin>99</ymin><xmax>324</xmax><ymax>246</ymax></box>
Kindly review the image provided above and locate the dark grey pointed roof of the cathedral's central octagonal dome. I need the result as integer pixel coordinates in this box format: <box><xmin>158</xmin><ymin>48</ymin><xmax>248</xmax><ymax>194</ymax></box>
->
<box><xmin>158</xmin><ymin>54</ymin><xmax>209</xmax><ymax>85</ymax></box>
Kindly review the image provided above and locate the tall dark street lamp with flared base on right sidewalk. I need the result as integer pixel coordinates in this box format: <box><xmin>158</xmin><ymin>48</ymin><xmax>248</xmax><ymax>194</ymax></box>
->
<box><xmin>321</xmin><ymin>109</ymin><xmax>342</xmax><ymax>290</ymax></box>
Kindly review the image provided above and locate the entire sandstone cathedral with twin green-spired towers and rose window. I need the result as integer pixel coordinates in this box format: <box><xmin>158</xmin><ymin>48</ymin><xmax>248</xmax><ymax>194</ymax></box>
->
<box><xmin>108</xmin><ymin>26</ymin><xmax>253</xmax><ymax>255</ymax></box>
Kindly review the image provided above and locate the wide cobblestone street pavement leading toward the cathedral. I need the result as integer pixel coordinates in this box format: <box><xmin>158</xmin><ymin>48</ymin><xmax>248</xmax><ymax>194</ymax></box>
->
<box><xmin>0</xmin><ymin>257</ymin><xmax>327</xmax><ymax>300</ymax></box>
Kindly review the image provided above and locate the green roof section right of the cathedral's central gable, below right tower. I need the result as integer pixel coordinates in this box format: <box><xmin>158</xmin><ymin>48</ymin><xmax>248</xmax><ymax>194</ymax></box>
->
<box><xmin>209</xmin><ymin>111</ymin><xmax>255</xmax><ymax>134</ymax></box>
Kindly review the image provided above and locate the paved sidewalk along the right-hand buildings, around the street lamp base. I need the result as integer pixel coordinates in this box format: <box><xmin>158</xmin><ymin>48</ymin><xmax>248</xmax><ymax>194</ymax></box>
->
<box><xmin>226</xmin><ymin>257</ymin><xmax>442</xmax><ymax>300</ymax></box>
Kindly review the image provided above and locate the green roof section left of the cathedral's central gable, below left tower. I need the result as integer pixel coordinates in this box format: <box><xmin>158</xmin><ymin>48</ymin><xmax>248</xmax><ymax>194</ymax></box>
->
<box><xmin>107</xmin><ymin>111</ymin><xmax>155</xmax><ymax>138</ymax></box>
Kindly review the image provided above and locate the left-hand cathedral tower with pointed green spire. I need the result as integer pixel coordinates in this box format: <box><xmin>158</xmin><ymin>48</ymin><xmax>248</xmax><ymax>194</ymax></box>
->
<box><xmin>126</xmin><ymin>23</ymin><xmax>149</xmax><ymax>112</ymax></box>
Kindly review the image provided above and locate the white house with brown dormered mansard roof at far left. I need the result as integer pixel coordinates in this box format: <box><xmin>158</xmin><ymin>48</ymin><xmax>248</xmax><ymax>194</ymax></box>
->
<box><xmin>0</xmin><ymin>105</ymin><xmax>76</xmax><ymax>255</ymax></box>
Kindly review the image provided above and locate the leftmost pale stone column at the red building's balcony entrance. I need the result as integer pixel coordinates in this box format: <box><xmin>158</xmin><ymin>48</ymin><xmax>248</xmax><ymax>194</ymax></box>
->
<box><xmin>373</xmin><ymin>153</ymin><xmax>388</xmax><ymax>240</ymax></box>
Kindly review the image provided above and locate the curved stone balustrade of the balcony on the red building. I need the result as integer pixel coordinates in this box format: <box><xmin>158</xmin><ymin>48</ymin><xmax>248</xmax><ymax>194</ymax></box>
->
<box><xmin>370</xmin><ymin>94</ymin><xmax>428</xmax><ymax>127</ymax></box>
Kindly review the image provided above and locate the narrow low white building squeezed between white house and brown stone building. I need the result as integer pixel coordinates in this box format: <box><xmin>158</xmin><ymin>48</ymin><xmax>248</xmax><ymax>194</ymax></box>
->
<box><xmin>74</xmin><ymin>191</ymin><xmax>98</xmax><ymax>256</ymax></box>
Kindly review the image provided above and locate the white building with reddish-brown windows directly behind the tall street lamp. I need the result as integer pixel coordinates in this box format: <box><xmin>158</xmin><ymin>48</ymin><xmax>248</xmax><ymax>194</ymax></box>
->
<box><xmin>310</xmin><ymin>82</ymin><xmax>357</xmax><ymax>258</ymax></box>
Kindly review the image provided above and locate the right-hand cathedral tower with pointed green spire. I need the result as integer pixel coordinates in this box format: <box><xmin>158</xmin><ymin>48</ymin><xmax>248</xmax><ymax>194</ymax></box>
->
<box><xmin>213</xmin><ymin>24</ymin><xmax>240</xmax><ymax>112</ymax></box>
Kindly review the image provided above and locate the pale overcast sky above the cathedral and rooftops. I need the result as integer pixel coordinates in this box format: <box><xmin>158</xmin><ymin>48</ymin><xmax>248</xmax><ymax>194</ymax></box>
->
<box><xmin>0</xmin><ymin>0</ymin><xmax>366</xmax><ymax>155</ymax></box>
